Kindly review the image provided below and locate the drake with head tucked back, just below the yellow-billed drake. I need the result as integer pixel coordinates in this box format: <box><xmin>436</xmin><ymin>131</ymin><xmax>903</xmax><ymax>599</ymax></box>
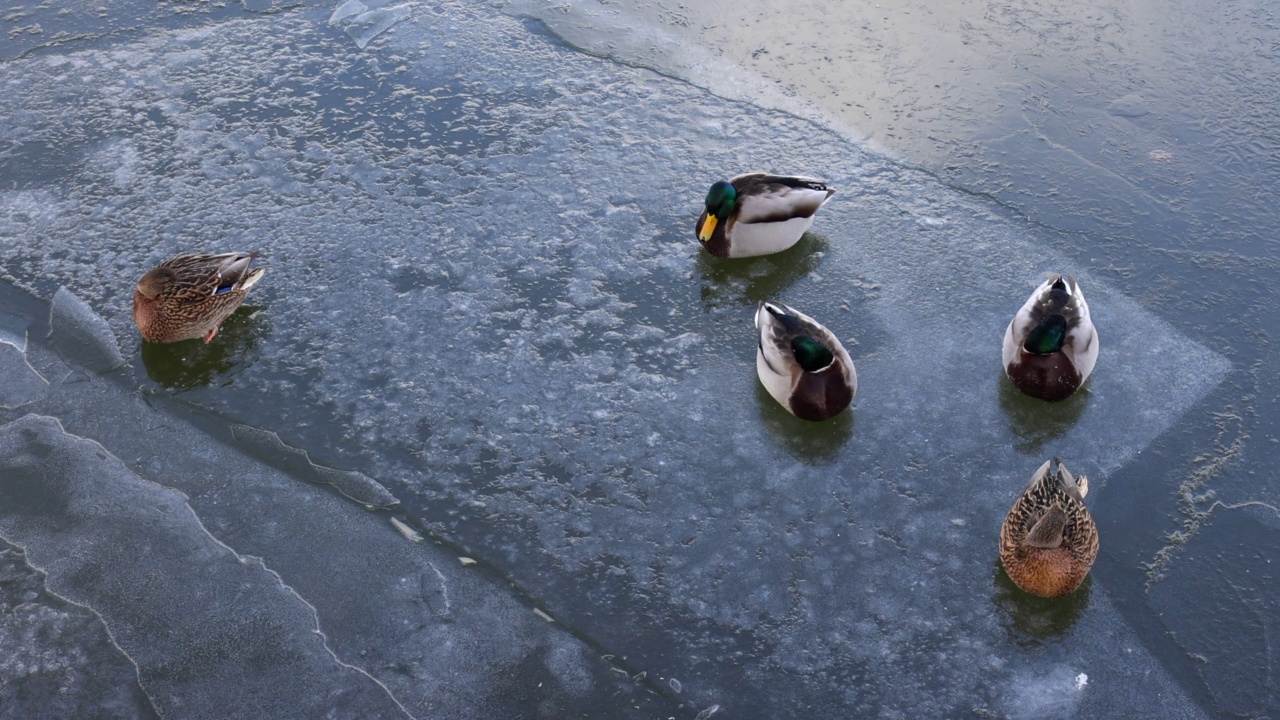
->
<box><xmin>755</xmin><ymin>302</ymin><xmax>858</xmax><ymax>420</ymax></box>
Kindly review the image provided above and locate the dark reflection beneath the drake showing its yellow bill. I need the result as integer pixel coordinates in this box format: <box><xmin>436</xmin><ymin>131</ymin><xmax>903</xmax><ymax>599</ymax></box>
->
<box><xmin>698</xmin><ymin>232</ymin><xmax>828</xmax><ymax>309</ymax></box>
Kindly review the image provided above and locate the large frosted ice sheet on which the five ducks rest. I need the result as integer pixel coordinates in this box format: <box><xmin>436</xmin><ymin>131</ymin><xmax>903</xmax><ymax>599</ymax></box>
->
<box><xmin>0</xmin><ymin>6</ymin><xmax>1226</xmax><ymax>717</ymax></box>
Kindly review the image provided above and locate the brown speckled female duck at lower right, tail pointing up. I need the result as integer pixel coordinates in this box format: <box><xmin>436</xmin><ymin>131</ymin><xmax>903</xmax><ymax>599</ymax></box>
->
<box><xmin>1000</xmin><ymin>457</ymin><xmax>1098</xmax><ymax>597</ymax></box>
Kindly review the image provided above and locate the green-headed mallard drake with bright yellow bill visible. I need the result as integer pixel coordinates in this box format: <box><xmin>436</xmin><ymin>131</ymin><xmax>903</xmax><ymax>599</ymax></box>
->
<box><xmin>696</xmin><ymin>173</ymin><xmax>836</xmax><ymax>258</ymax></box>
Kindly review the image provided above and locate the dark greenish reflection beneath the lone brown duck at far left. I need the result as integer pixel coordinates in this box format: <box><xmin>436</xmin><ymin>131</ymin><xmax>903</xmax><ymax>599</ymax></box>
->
<box><xmin>140</xmin><ymin>305</ymin><xmax>270</xmax><ymax>391</ymax></box>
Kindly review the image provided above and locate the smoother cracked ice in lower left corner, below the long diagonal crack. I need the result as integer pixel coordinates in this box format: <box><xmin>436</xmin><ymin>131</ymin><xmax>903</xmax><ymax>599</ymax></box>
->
<box><xmin>0</xmin><ymin>313</ymin><xmax>675</xmax><ymax>720</ymax></box>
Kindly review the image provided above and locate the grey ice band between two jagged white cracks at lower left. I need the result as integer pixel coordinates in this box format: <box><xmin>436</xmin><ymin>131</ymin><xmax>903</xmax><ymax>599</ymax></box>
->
<box><xmin>0</xmin><ymin>415</ymin><xmax>403</xmax><ymax>719</ymax></box>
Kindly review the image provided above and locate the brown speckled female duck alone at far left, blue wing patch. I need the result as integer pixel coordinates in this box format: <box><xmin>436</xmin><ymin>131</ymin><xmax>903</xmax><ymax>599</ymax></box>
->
<box><xmin>133</xmin><ymin>252</ymin><xmax>266</xmax><ymax>343</ymax></box>
